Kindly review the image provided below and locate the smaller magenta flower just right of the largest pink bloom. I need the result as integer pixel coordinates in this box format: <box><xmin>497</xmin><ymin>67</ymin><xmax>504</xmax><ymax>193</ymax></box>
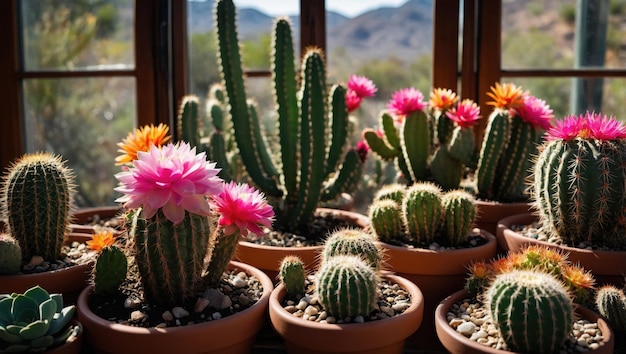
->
<box><xmin>211</xmin><ymin>182</ymin><xmax>274</xmax><ymax>237</ymax></box>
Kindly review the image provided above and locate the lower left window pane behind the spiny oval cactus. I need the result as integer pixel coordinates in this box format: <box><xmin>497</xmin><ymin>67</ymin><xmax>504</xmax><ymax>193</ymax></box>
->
<box><xmin>23</xmin><ymin>78</ymin><xmax>136</xmax><ymax>207</ymax></box>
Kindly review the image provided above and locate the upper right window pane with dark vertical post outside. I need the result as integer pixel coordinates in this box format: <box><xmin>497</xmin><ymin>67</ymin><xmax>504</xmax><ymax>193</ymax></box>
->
<box><xmin>502</xmin><ymin>0</ymin><xmax>626</xmax><ymax>69</ymax></box>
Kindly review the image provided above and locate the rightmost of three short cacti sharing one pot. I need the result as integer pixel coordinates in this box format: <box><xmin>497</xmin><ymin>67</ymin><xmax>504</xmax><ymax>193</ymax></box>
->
<box><xmin>441</xmin><ymin>189</ymin><xmax>476</xmax><ymax>245</ymax></box>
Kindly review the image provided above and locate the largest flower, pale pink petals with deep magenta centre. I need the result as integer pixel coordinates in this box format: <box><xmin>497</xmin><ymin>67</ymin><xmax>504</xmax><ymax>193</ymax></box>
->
<box><xmin>114</xmin><ymin>143</ymin><xmax>222</xmax><ymax>225</ymax></box>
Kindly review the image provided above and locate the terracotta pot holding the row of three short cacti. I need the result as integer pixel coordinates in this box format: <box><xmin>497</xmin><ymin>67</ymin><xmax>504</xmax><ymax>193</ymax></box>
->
<box><xmin>380</xmin><ymin>230</ymin><xmax>497</xmax><ymax>350</ymax></box>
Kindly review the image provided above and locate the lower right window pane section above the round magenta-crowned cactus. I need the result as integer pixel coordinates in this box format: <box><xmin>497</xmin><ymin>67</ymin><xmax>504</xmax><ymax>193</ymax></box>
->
<box><xmin>502</xmin><ymin>77</ymin><xmax>626</xmax><ymax>120</ymax></box>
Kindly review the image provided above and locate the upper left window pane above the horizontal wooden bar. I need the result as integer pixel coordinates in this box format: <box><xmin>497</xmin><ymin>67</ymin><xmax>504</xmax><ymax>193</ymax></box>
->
<box><xmin>20</xmin><ymin>0</ymin><xmax>134</xmax><ymax>71</ymax></box>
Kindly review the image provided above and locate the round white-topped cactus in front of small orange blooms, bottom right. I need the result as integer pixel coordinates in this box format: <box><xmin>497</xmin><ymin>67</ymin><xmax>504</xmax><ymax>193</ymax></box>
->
<box><xmin>485</xmin><ymin>270</ymin><xmax>574</xmax><ymax>353</ymax></box>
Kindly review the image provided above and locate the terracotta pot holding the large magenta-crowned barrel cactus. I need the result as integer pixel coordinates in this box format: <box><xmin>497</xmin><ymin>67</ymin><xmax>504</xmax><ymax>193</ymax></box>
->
<box><xmin>496</xmin><ymin>213</ymin><xmax>626</xmax><ymax>287</ymax></box>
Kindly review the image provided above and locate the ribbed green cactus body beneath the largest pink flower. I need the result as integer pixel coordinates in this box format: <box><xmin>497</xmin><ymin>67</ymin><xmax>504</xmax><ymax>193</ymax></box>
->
<box><xmin>126</xmin><ymin>209</ymin><xmax>214</xmax><ymax>304</ymax></box>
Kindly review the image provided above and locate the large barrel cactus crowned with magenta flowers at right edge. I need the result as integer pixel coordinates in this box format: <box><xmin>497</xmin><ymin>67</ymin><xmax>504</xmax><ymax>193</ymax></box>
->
<box><xmin>531</xmin><ymin>113</ymin><xmax>626</xmax><ymax>247</ymax></box>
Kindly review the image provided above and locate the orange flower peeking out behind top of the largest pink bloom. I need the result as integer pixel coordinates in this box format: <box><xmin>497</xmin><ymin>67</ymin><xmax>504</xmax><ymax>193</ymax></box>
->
<box><xmin>115</xmin><ymin>123</ymin><xmax>171</xmax><ymax>165</ymax></box>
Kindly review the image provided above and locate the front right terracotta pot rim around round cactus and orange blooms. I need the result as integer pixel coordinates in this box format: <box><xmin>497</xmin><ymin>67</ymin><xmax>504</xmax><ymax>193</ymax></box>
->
<box><xmin>435</xmin><ymin>290</ymin><xmax>615</xmax><ymax>354</ymax></box>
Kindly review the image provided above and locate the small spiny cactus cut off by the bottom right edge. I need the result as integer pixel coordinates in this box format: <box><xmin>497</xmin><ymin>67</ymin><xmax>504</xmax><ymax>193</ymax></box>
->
<box><xmin>595</xmin><ymin>285</ymin><xmax>626</xmax><ymax>341</ymax></box>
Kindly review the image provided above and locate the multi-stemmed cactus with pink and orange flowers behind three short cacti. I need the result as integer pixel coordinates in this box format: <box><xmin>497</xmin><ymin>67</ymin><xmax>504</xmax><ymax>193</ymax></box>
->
<box><xmin>362</xmin><ymin>88</ymin><xmax>479</xmax><ymax>190</ymax></box>
